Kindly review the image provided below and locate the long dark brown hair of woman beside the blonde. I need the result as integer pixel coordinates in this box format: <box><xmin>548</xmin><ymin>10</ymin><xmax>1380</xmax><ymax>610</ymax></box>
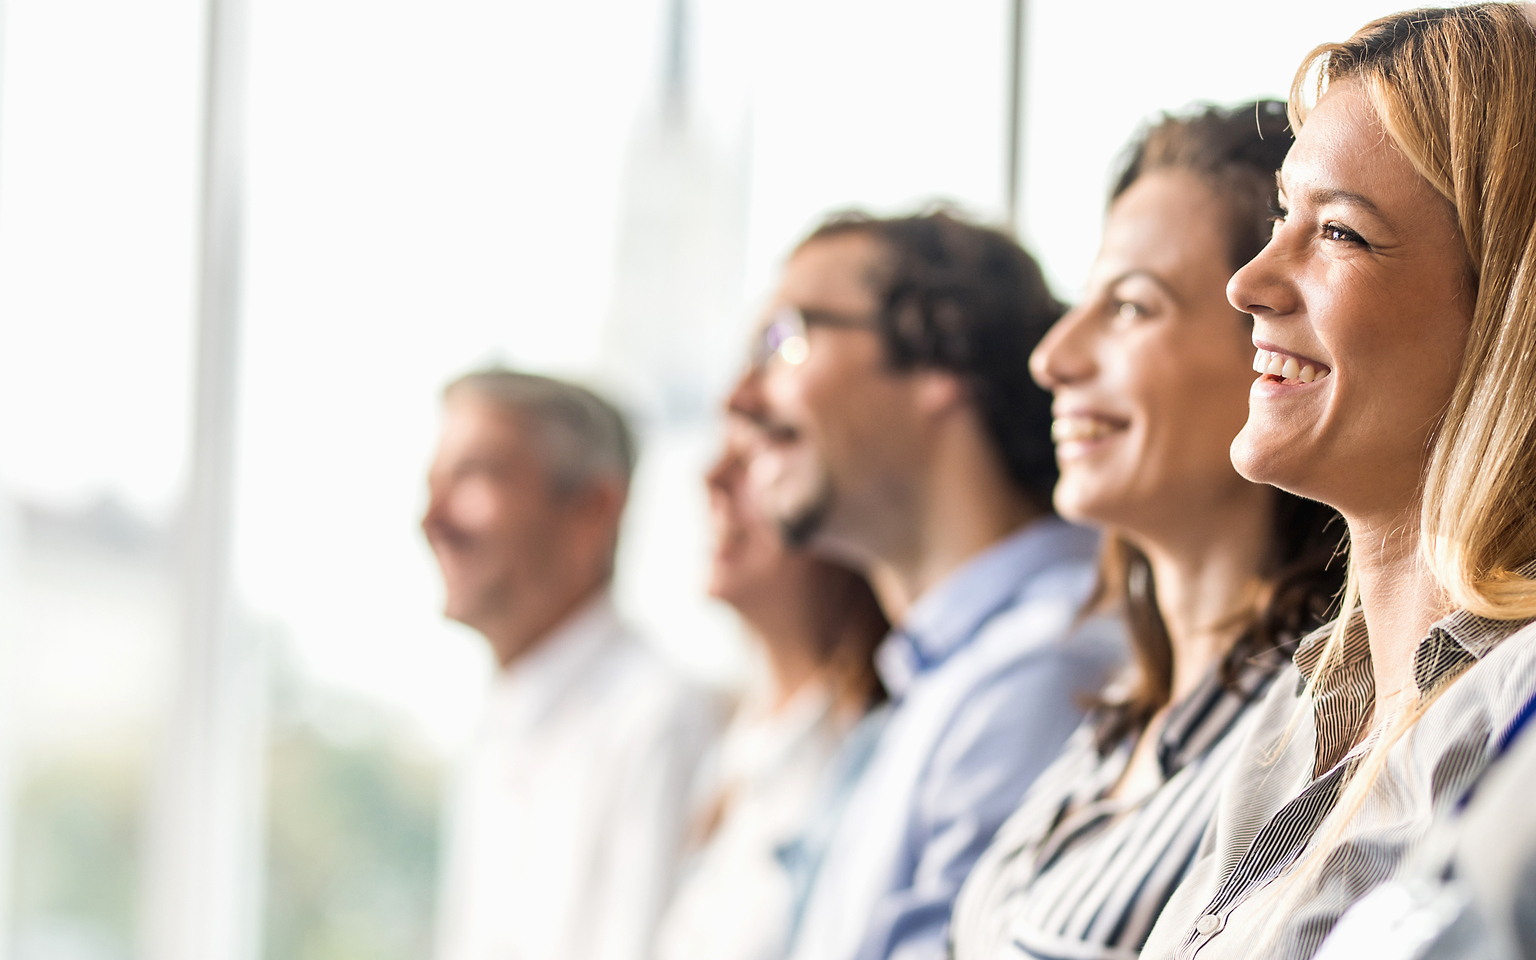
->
<box><xmin>1087</xmin><ymin>100</ymin><xmax>1347</xmax><ymax>751</ymax></box>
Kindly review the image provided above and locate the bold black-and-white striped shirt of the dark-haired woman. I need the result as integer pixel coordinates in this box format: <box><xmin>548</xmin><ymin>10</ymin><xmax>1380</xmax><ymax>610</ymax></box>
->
<box><xmin>951</xmin><ymin>650</ymin><xmax>1287</xmax><ymax>960</ymax></box>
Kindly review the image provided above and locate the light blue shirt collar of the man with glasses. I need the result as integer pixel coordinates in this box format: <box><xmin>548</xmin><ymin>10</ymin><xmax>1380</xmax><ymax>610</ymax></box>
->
<box><xmin>876</xmin><ymin>516</ymin><xmax>1098</xmax><ymax>699</ymax></box>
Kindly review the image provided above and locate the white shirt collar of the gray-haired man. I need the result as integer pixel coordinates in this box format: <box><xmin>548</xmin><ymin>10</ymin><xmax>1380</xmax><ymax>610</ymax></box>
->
<box><xmin>487</xmin><ymin>588</ymin><xmax>624</xmax><ymax>730</ymax></box>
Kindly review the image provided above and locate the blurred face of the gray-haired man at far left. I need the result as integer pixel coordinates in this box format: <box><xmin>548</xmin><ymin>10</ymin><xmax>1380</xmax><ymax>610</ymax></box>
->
<box><xmin>421</xmin><ymin>392</ymin><xmax>567</xmax><ymax>648</ymax></box>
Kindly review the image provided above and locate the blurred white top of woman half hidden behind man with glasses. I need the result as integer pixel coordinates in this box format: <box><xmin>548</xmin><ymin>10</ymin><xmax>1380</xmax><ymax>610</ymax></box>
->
<box><xmin>656</xmin><ymin>684</ymin><xmax>857</xmax><ymax>960</ymax></box>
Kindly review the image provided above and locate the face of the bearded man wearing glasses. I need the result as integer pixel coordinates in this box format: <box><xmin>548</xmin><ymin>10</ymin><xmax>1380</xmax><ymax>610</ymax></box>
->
<box><xmin>730</xmin><ymin>233</ymin><xmax>915</xmax><ymax>561</ymax></box>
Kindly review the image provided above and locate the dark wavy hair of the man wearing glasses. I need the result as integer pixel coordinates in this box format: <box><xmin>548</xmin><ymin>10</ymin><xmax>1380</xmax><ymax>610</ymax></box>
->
<box><xmin>800</xmin><ymin>209</ymin><xmax>1066</xmax><ymax>510</ymax></box>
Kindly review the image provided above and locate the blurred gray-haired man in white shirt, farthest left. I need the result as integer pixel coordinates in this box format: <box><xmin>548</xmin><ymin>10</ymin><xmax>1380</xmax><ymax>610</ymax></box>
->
<box><xmin>421</xmin><ymin>370</ymin><xmax>717</xmax><ymax>960</ymax></box>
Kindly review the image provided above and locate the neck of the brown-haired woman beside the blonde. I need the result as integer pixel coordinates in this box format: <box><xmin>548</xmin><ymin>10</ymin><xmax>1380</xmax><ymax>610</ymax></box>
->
<box><xmin>1132</xmin><ymin>484</ymin><xmax>1273</xmax><ymax>703</ymax></box>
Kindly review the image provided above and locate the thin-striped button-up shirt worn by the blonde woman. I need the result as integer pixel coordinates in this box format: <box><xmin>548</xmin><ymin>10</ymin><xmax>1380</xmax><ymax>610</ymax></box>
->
<box><xmin>1143</xmin><ymin>595</ymin><xmax>1536</xmax><ymax>960</ymax></box>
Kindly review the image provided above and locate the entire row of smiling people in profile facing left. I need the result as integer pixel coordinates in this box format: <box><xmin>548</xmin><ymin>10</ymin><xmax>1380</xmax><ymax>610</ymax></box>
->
<box><xmin>424</xmin><ymin>2</ymin><xmax>1536</xmax><ymax>960</ymax></box>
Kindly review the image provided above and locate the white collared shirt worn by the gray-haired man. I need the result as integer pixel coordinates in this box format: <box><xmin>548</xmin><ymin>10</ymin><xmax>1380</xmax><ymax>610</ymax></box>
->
<box><xmin>436</xmin><ymin>594</ymin><xmax>717</xmax><ymax>960</ymax></box>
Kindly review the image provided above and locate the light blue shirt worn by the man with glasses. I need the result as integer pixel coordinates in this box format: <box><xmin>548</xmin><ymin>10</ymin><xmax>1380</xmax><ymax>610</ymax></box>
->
<box><xmin>791</xmin><ymin>518</ymin><xmax>1124</xmax><ymax>960</ymax></box>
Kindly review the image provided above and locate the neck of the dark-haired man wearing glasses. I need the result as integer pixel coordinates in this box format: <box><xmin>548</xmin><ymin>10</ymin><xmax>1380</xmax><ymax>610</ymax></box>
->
<box><xmin>876</xmin><ymin>427</ymin><xmax>1046</xmax><ymax>622</ymax></box>
